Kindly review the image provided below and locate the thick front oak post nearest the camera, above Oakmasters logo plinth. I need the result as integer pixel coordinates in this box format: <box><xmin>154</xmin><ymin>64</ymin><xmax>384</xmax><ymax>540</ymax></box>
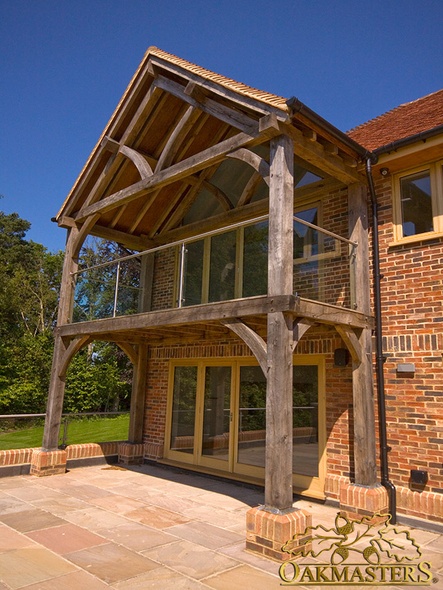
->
<box><xmin>265</xmin><ymin>135</ymin><xmax>294</xmax><ymax>511</ymax></box>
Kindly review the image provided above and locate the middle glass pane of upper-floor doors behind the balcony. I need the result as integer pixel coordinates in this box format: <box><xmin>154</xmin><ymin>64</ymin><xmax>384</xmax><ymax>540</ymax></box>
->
<box><xmin>209</xmin><ymin>231</ymin><xmax>237</xmax><ymax>301</ymax></box>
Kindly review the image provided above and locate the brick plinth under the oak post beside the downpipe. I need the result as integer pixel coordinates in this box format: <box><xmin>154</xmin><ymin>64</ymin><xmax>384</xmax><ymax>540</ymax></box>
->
<box><xmin>340</xmin><ymin>484</ymin><xmax>389</xmax><ymax>518</ymax></box>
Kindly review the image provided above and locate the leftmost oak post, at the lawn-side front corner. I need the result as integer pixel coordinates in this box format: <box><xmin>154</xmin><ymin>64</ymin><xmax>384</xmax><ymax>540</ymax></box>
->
<box><xmin>42</xmin><ymin>227</ymin><xmax>79</xmax><ymax>451</ymax></box>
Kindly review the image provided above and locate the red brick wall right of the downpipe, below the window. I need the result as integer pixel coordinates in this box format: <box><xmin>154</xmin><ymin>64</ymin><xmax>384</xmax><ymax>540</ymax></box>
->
<box><xmin>376</xmin><ymin>178</ymin><xmax>443</xmax><ymax>500</ymax></box>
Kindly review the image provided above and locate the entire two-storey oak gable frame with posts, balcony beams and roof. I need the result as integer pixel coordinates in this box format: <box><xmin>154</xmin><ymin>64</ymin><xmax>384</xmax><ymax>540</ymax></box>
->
<box><xmin>43</xmin><ymin>48</ymin><xmax>376</xmax><ymax>510</ymax></box>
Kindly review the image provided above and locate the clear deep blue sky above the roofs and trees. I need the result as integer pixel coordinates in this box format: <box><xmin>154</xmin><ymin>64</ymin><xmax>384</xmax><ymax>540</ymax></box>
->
<box><xmin>0</xmin><ymin>0</ymin><xmax>443</xmax><ymax>251</ymax></box>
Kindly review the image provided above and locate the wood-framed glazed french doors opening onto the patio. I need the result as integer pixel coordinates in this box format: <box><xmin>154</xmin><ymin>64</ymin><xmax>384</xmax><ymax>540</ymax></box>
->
<box><xmin>165</xmin><ymin>355</ymin><xmax>326</xmax><ymax>497</ymax></box>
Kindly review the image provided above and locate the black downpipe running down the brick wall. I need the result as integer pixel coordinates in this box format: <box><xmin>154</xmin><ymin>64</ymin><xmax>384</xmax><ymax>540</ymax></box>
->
<box><xmin>366</xmin><ymin>158</ymin><xmax>397</xmax><ymax>524</ymax></box>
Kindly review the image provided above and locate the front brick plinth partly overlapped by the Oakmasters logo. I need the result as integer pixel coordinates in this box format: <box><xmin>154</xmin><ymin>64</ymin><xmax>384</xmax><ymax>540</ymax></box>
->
<box><xmin>246</xmin><ymin>506</ymin><xmax>312</xmax><ymax>561</ymax></box>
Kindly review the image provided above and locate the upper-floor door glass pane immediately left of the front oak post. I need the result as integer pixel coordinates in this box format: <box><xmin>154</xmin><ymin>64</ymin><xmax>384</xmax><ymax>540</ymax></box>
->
<box><xmin>243</xmin><ymin>223</ymin><xmax>268</xmax><ymax>297</ymax></box>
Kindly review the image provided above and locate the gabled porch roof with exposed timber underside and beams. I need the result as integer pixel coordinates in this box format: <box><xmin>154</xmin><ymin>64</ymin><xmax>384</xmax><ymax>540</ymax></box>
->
<box><xmin>57</xmin><ymin>48</ymin><xmax>366</xmax><ymax>248</ymax></box>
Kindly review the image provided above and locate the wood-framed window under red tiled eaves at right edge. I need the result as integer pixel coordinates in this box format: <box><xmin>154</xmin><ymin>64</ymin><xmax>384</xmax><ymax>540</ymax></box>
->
<box><xmin>394</xmin><ymin>162</ymin><xmax>443</xmax><ymax>241</ymax></box>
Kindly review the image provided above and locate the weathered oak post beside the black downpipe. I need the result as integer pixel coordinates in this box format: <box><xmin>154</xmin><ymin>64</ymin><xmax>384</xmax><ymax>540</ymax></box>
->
<box><xmin>348</xmin><ymin>184</ymin><xmax>377</xmax><ymax>486</ymax></box>
